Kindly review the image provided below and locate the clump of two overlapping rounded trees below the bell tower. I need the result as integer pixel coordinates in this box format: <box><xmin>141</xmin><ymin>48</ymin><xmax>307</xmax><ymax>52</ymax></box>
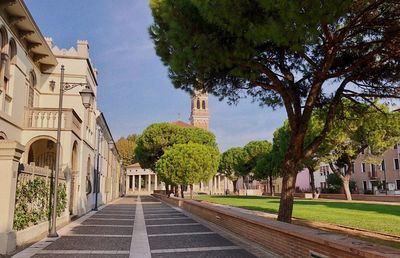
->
<box><xmin>135</xmin><ymin>123</ymin><xmax>220</xmax><ymax>197</ymax></box>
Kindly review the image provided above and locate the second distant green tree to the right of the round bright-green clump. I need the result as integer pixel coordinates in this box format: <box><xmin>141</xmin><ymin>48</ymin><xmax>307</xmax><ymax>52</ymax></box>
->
<box><xmin>235</xmin><ymin>141</ymin><xmax>272</xmax><ymax>190</ymax></box>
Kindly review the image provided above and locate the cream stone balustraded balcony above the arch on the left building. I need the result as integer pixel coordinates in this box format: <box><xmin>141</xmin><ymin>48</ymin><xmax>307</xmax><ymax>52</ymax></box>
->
<box><xmin>24</xmin><ymin>108</ymin><xmax>82</xmax><ymax>137</ymax></box>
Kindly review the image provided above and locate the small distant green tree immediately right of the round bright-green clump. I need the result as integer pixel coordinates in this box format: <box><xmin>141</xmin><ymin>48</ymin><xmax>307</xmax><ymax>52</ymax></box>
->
<box><xmin>218</xmin><ymin>147</ymin><xmax>243</xmax><ymax>193</ymax></box>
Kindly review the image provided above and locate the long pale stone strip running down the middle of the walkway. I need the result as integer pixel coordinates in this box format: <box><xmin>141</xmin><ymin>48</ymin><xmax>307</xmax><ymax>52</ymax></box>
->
<box><xmin>129</xmin><ymin>196</ymin><xmax>151</xmax><ymax>258</ymax></box>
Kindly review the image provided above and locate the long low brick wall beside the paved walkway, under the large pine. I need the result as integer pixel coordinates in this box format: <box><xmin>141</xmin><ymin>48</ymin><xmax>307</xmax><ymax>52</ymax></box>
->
<box><xmin>153</xmin><ymin>194</ymin><xmax>400</xmax><ymax>258</ymax></box>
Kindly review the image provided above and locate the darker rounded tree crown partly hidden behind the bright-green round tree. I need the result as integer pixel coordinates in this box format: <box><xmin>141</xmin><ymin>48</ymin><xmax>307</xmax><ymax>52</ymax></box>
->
<box><xmin>135</xmin><ymin>123</ymin><xmax>217</xmax><ymax>170</ymax></box>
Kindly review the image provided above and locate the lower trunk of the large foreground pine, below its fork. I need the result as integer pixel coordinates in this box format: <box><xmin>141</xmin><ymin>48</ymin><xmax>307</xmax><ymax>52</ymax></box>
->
<box><xmin>278</xmin><ymin>159</ymin><xmax>298</xmax><ymax>223</ymax></box>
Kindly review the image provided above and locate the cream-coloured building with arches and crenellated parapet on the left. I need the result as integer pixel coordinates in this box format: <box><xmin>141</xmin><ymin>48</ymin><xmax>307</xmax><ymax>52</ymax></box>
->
<box><xmin>0</xmin><ymin>0</ymin><xmax>123</xmax><ymax>254</ymax></box>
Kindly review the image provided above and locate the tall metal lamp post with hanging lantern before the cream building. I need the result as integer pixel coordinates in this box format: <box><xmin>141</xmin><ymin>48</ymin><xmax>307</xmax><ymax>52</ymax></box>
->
<box><xmin>48</xmin><ymin>65</ymin><xmax>94</xmax><ymax>237</ymax></box>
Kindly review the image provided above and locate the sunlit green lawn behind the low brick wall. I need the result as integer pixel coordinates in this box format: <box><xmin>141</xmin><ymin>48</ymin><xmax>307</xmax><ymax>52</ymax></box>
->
<box><xmin>196</xmin><ymin>196</ymin><xmax>400</xmax><ymax>236</ymax></box>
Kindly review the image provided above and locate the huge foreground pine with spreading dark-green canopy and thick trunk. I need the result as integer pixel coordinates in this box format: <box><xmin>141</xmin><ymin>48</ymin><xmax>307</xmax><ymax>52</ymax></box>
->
<box><xmin>149</xmin><ymin>0</ymin><xmax>400</xmax><ymax>222</ymax></box>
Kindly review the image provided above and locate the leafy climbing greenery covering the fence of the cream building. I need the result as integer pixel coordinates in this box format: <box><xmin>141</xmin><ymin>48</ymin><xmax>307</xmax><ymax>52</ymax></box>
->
<box><xmin>14</xmin><ymin>177</ymin><xmax>67</xmax><ymax>230</ymax></box>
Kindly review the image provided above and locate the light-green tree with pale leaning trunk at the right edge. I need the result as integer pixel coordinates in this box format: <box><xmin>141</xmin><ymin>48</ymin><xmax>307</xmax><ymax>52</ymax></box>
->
<box><xmin>324</xmin><ymin>101</ymin><xmax>400</xmax><ymax>200</ymax></box>
